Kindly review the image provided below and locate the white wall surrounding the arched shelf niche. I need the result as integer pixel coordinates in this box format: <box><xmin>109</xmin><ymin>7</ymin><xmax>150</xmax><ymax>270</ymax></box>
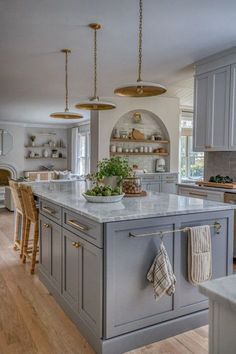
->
<box><xmin>98</xmin><ymin>96</ymin><xmax>180</xmax><ymax>172</ymax></box>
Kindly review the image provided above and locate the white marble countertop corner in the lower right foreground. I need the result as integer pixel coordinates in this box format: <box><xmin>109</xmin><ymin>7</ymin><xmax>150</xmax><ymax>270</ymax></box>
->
<box><xmin>198</xmin><ymin>274</ymin><xmax>236</xmax><ymax>311</ymax></box>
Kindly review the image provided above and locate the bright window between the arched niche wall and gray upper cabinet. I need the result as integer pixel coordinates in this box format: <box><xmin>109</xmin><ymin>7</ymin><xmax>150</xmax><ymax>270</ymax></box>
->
<box><xmin>180</xmin><ymin>112</ymin><xmax>204</xmax><ymax>180</ymax></box>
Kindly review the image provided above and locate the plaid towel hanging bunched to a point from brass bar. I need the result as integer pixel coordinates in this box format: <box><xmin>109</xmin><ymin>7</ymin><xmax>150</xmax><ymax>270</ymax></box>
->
<box><xmin>147</xmin><ymin>242</ymin><xmax>176</xmax><ymax>300</ymax></box>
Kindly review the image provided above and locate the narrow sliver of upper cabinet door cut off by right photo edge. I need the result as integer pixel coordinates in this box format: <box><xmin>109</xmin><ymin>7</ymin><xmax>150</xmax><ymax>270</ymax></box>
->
<box><xmin>229</xmin><ymin>64</ymin><xmax>236</xmax><ymax>150</ymax></box>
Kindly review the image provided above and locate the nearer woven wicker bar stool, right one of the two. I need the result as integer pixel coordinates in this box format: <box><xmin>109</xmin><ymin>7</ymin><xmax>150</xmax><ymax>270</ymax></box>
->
<box><xmin>20</xmin><ymin>184</ymin><xmax>39</xmax><ymax>274</ymax></box>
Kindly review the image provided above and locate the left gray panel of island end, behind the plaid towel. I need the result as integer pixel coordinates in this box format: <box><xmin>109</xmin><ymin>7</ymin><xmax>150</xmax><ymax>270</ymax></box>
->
<box><xmin>105</xmin><ymin>219</ymin><xmax>175</xmax><ymax>338</ymax></box>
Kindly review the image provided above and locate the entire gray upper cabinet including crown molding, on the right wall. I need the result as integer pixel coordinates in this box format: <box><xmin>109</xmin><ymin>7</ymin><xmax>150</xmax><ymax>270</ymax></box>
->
<box><xmin>193</xmin><ymin>48</ymin><xmax>236</xmax><ymax>151</ymax></box>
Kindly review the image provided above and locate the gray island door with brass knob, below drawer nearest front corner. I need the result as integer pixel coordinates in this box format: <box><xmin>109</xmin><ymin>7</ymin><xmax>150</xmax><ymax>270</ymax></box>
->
<box><xmin>62</xmin><ymin>230</ymin><xmax>103</xmax><ymax>337</ymax></box>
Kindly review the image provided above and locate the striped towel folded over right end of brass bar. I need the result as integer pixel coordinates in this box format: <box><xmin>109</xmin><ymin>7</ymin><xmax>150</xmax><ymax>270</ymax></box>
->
<box><xmin>188</xmin><ymin>225</ymin><xmax>212</xmax><ymax>285</ymax></box>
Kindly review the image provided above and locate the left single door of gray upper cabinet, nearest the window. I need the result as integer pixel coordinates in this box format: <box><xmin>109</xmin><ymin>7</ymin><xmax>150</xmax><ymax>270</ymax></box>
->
<box><xmin>193</xmin><ymin>73</ymin><xmax>210</xmax><ymax>151</ymax></box>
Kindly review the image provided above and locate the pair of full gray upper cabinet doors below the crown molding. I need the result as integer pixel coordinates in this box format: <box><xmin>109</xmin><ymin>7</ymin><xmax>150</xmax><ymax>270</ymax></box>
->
<box><xmin>194</xmin><ymin>65</ymin><xmax>230</xmax><ymax>151</ymax></box>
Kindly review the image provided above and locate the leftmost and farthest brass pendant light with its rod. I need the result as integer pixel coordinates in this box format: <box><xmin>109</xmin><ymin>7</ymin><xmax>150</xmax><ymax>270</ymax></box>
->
<box><xmin>50</xmin><ymin>49</ymin><xmax>83</xmax><ymax>119</ymax></box>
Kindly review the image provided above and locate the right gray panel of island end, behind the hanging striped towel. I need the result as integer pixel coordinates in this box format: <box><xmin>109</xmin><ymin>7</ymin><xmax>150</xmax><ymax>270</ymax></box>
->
<box><xmin>175</xmin><ymin>216</ymin><xmax>232</xmax><ymax>314</ymax></box>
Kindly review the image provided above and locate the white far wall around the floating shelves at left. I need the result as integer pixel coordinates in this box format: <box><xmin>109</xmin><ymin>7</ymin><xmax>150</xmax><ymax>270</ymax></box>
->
<box><xmin>0</xmin><ymin>121</ymin><xmax>67</xmax><ymax>176</ymax></box>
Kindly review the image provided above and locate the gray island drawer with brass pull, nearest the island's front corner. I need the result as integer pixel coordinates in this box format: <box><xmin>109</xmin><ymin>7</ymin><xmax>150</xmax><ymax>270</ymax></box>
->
<box><xmin>63</xmin><ymin>209</ymin><xmax>103</xmax><ymax>248</ymax></box>
